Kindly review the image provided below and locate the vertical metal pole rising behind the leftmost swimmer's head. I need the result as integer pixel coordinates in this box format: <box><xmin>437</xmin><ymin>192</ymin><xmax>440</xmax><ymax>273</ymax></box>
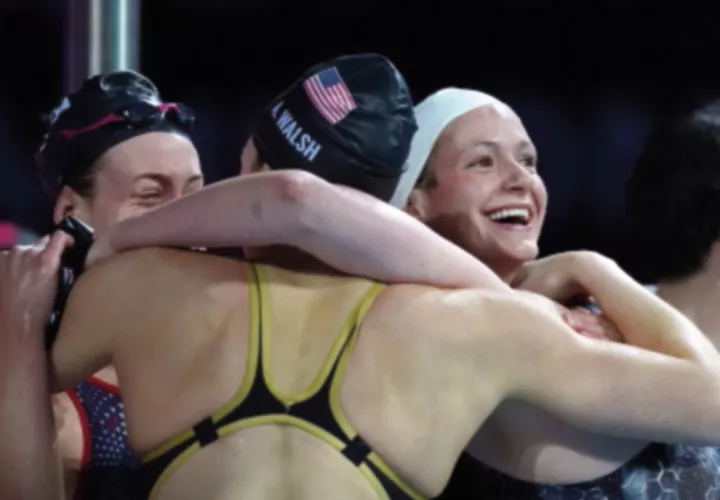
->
<box><xmin>65</xmin><ymin>0</ymin><xmax>140</xmax><ymax>92</ymax></box>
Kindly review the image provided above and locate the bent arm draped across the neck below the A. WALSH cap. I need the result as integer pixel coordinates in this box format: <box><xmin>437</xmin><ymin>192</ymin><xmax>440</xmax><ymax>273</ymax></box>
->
<box><xmin>90</xmin><ymin>170</ymin><xmax>510</xmax><ymax>291</ymax></box>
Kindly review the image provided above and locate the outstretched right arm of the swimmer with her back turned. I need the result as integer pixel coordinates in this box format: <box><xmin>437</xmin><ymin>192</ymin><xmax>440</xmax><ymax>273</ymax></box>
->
<box><xmin>478</xmin><ymin>290</ymin><xmax>720</xmax><ymax>445</ymax></box>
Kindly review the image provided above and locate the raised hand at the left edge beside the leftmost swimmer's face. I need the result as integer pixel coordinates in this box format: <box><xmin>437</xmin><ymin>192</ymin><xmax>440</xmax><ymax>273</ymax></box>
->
<box><xmin>0</xmin><ymin>231</ymin><xmax>73</xmax><ymax>336</ymax></box>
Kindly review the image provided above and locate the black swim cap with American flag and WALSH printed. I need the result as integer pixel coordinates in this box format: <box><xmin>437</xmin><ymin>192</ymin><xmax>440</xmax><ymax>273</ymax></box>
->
<box><xmin>253</xmin><ymin>54</ymin><xmax>417</xmax><ymax>201</ymax></box>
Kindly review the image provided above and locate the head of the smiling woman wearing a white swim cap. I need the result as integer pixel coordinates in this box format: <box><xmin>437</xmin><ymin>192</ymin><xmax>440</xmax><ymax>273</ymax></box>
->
<box><xmin>404</xmin><ymin>89</ymin><xmax>547</xmax><ymax>282</ymax></box>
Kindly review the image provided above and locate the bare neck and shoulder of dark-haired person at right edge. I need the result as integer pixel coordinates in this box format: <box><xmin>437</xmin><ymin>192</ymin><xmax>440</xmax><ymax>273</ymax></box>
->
<box><xmin>657</xmin><ymin>254</ymin><xmax>720</xmax><ymax>348</ymax></box>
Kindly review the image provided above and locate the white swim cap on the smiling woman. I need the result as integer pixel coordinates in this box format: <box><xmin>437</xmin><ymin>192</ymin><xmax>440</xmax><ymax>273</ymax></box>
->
<box><xmin>390</xmin><ymin>87</ymin><xmax>502</xmax><ymax>208</ymax></box>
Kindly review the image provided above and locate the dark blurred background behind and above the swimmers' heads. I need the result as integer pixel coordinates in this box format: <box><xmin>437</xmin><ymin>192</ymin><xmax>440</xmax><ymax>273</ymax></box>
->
<box><xmin>0</xmin><ymin>0</ymin><xmax>720</xmax><ymax>278</ymax></box>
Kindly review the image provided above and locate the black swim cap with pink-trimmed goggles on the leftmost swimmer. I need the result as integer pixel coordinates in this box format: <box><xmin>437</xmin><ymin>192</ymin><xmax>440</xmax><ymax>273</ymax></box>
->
<box><xmin>35</xmin><ymin>71</ymin><xmax>195</xmax><ymax>198</ymax></box>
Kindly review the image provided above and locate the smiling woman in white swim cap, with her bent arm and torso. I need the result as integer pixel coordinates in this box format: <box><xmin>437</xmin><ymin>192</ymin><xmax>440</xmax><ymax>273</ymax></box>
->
<box><xmin>395</xmin><ymin>89</ymin><xmax>714</xmax><ymax>499</ymax></box>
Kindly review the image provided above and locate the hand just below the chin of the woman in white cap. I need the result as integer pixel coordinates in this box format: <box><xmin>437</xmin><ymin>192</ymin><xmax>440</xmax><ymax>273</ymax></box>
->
<box><xmin>511</xmin><ymin>251</ymin><xmax>604</xmax><ymax>304</ymax></box>
